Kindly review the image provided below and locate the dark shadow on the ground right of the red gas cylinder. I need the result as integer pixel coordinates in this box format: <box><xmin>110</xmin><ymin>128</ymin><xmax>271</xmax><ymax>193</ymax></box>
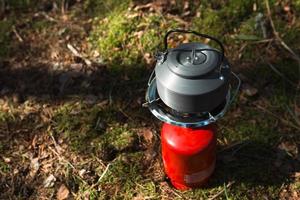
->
<box><xmin>211</xmin><ymin>141</ymin><xmax>300</xmax><ymax>187</ymax></box>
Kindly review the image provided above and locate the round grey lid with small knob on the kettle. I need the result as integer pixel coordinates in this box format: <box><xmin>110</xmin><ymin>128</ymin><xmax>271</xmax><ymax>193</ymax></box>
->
<box><xmin>166</xmin><ymin>42</ymin><xmax>221</xmax><ymax>78</ymax></box>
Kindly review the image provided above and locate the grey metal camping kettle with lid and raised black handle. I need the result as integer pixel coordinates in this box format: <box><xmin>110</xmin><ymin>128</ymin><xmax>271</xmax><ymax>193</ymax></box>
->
<box><xmin>155</xmin><ymin>30</ymin><xmax>230</xmax><ymax>113</ymax></box>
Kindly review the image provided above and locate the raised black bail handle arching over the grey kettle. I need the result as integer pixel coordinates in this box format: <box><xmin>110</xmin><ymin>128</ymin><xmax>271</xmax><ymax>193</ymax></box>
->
<box><xmin>164</xmin><ymin>29</ymin><xmax>225</xmax><ymax>63</ymax></box>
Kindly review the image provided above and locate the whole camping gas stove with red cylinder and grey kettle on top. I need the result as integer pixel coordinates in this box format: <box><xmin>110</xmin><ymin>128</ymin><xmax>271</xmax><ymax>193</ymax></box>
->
<box><xmin>145</xmin><ymin>29</ymin><xmax>240</xmax><ymax>190</ymax></box>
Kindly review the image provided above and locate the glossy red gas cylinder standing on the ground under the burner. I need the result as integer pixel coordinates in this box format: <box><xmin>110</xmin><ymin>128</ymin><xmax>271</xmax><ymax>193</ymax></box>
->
<box><xmin>161</xmin><ymin>123</ymin><xmax>216</xmax><ymax>190</ymax></box>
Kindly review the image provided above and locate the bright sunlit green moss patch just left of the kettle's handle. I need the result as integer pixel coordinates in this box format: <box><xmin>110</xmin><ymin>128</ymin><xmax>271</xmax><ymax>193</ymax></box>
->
<box><xmin>90</xmin><ymin>9</ymin><xmax>178</xmax><ymax>67</ymax></box>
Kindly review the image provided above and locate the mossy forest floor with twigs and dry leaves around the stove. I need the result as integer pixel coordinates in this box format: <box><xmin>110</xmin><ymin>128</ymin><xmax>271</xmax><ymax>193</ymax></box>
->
<box><xmin>0</xmin><ymin>0</ymin><xmax>300</xmax><ymax>200</ymax></box>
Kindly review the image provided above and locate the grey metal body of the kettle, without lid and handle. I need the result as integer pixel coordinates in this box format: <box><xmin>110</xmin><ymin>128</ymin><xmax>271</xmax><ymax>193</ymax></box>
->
<box><xmin>155</xmin><ymin>45</ymin><xmax>230</xmax><ymax>113</ymax></box>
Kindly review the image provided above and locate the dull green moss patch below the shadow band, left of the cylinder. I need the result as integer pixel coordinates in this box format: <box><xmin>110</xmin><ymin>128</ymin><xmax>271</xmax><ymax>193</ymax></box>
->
<box><xmin>53</xmin><ymin>104</ymin><xmax>137</xmax><ymax>157</ymax></box>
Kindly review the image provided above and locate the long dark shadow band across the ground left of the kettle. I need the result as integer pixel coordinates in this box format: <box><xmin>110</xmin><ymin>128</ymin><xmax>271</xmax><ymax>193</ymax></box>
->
<box><xmin>0</xmin><ymin>63</ymin><xmax>150</xmax><ymax>103</ymax></box>
